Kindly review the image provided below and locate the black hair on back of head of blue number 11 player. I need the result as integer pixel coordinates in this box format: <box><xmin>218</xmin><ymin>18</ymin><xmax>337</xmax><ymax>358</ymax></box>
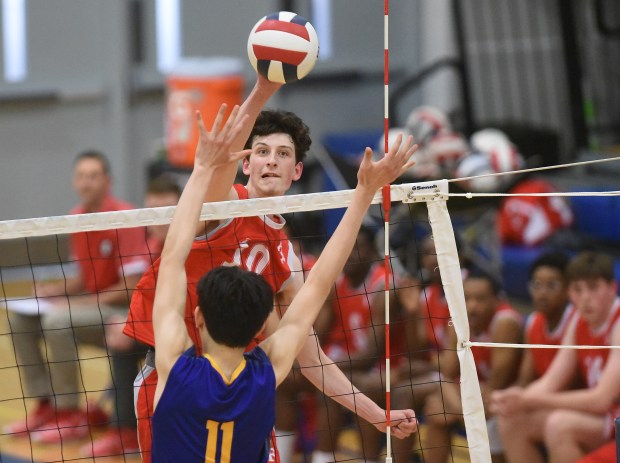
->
<box><xmin>196</xmin><ymin>266</ymin><xmax>273</xmax><ymax>347</ymax></box>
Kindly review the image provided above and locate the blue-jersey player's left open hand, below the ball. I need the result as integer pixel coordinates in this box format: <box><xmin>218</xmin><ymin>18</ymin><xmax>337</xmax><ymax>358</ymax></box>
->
<box><xmin>194</xmin><ymin>103</ymin><xmax>250</xmax><ymax>169</ymax></box>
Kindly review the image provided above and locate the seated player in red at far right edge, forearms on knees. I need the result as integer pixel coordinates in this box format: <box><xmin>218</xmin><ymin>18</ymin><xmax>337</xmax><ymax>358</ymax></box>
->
<box><xmin>493</xmin><ymin>252</ymin><xmax>620</xmax><ymax>463</ymax></box>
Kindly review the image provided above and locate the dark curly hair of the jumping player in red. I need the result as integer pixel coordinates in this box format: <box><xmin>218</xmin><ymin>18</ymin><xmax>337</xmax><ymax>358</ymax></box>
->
<box><xmin>245</xmin><ymin>109</ymin><xmax>312</xmax><ymax>162</ymax></box>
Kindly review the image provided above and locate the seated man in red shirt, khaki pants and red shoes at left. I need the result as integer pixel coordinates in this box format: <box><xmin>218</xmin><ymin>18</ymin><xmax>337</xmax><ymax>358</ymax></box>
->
<box><xmin>5</xmin><ymin>151</ymin><xmax>149</xmax><ymax>455</ymax></box>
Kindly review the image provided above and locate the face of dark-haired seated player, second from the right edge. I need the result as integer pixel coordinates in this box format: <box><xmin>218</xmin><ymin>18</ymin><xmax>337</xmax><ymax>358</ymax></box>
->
<box><xmin>529</xmin><ymin>266</ymin><xmax>568</xmax><ymax>315</ymax></box>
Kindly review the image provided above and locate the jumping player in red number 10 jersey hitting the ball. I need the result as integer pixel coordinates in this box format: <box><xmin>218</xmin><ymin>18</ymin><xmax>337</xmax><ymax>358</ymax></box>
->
<box><xmin>125</xmin><ymin>76</ymin><xmax>418</xmax><ymax>462</ymax></box>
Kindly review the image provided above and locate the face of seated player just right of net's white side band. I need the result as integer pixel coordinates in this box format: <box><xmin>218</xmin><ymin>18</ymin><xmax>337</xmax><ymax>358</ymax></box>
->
<box><xmin>463</xmin><ymin>278</ymin><xmax>499</xmax><ymax>335</ymax></box>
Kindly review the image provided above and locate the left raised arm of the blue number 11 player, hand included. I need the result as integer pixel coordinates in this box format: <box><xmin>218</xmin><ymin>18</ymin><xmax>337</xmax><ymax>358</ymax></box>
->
<box><xmin>153</xmin><ymin>105</ymin><xmax>247</xmax><ymax>391</ymax></box>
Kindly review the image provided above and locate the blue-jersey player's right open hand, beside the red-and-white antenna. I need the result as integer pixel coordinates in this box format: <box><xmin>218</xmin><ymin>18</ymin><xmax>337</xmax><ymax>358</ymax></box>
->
<box><xmin>357</xmin><ymin>134</ymin><xmax>418</xmax><ymax>193</ymax></box>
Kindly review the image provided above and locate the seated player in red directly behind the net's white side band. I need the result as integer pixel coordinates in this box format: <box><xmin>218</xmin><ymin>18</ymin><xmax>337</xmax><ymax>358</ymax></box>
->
<box><xmin>423</xmin><ymin>271</ymin><xmax>527</xmax><ymax>463</ymax></box>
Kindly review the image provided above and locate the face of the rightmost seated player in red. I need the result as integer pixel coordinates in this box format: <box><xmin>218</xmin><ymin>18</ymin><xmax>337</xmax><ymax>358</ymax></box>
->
<box><xmin>568</xmin><ymin>278</ymin><xmax>617</xmax><ymax>328</ymax></box>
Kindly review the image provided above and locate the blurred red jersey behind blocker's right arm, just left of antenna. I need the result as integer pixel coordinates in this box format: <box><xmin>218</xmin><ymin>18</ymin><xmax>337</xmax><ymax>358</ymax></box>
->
<box><xmin>325</xmin><ymin>262</ymin><xmax>385</xmax><ymax>360</ymax></box>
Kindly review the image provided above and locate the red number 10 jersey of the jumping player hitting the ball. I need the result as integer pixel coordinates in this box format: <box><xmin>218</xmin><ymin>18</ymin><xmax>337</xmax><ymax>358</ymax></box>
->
<box><xmin>123</xmin><ymin>185</ymin><xmax>294</xmax><ymax>348</ymax></box>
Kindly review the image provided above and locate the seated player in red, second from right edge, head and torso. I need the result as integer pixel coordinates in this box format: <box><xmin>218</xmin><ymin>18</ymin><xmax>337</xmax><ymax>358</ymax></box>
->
<box><xmin>517</xmin><ymin>252</ymin><xmax>575</xmax><ymax>387</ymax></box>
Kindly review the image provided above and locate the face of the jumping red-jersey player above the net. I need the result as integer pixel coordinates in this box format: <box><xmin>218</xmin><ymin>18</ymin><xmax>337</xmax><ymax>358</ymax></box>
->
<box><xmin>243</xmin><ymin>133</ymin><xmax>303</xmax><ymax>198</ymax></box>
